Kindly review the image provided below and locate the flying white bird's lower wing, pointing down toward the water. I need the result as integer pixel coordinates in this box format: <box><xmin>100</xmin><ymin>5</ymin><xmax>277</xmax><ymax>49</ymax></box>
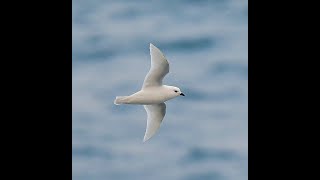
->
<box><xmin>143</xmin><ymin>103</ymin><xmax>166</xmax><ymax>142</ymax></box>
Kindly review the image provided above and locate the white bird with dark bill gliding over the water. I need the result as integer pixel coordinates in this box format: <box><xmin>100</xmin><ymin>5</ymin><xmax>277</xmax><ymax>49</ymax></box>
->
<box><xmin>114</xmin><ymin>43</ymin><xmax>185</xmax><ymax>142</ymax></box>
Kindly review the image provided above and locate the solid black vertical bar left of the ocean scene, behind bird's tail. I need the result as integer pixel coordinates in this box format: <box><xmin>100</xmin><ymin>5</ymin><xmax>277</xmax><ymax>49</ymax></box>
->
<box><xmin>1</xmin><ymin>0</ymin><xmax>72</xmax><ymax>180</ymax></box>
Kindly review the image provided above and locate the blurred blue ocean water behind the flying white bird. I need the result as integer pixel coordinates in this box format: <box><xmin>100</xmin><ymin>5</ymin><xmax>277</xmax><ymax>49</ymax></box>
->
<box><xmin>72</xmin><ymin>0</ymin><xmax>248</xmax><ymax>180</ymax></box>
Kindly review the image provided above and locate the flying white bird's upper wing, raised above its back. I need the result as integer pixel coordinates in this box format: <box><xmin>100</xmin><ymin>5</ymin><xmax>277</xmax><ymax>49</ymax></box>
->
<box><xmin>142</xmin><ymin>43</ymin><xmax>169</xmax><ymax>89</ymax></box>
